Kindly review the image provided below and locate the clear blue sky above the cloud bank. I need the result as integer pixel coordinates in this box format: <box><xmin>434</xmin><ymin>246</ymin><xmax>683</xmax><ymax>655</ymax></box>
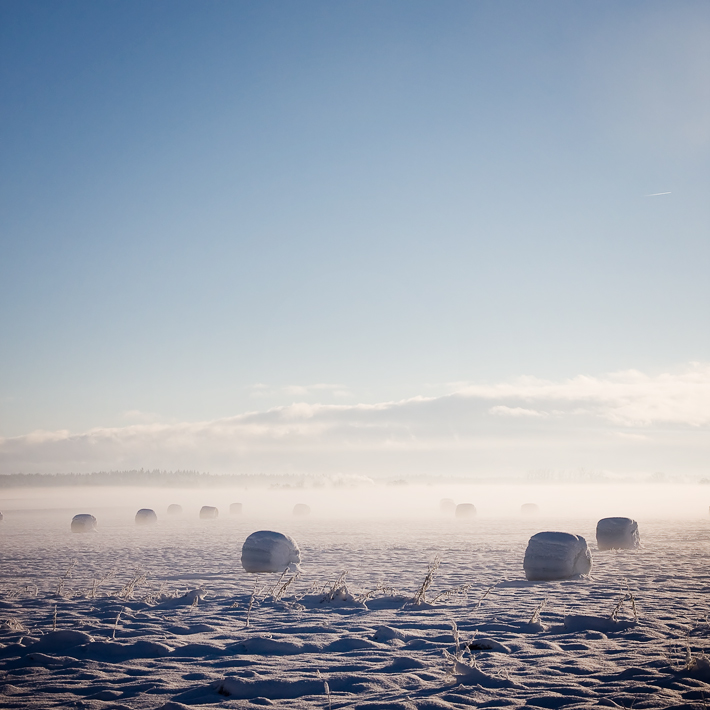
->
<box><xmin>0</xmin><ymin>0</ymin><xmax>710</xmax><ymax>478</ymax></box>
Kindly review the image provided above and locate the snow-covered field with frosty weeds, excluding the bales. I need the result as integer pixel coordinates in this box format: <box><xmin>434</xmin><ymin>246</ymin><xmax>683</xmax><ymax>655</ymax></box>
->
<box><xmin>0</xmin><ymin>496</ymin><xmax>710</xmax><ymax>710</ymax></box>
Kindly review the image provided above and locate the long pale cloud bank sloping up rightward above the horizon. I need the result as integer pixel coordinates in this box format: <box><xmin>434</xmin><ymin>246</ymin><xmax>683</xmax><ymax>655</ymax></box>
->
<box><xmin>0</xmin><ymin>363</ymin><xmax>710</xmax><ymax>477</ymax></box>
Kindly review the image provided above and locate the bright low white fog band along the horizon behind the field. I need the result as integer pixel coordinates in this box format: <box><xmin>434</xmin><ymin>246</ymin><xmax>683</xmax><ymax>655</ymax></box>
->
<box><xmin>0</xmin><ymin>483</ymin><xmax>710</xmax><ymax>525</ymax></box>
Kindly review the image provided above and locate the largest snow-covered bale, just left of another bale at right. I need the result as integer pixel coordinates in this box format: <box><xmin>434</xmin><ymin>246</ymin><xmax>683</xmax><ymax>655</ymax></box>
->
<box><xmin>523</xmin><ymin>532</ymin><xmax>592</xmax><ymax>580</ymax></box>
